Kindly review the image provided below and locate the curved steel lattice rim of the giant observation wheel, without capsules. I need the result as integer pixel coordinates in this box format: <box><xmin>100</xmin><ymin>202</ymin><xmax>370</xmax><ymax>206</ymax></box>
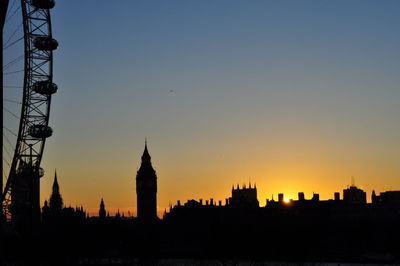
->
<box><xmin>1</xmin><ymin>0</ymin><xmax>58</xmax><ymax>220</ymax></box>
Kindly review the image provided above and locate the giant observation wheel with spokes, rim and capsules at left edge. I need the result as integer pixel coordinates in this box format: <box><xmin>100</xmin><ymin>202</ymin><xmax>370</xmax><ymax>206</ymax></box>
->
<box><xmin>1</xmin><ymin>0</ymin><xmax>58</xmax><ymax>222</ymax></box>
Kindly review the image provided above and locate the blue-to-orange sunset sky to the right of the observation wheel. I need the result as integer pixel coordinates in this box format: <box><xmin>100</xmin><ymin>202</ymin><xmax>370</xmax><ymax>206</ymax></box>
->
<box><xmin>7</xmin><ymin>0</ymin><xmax>400</xmax><ymax>215</ymax></box>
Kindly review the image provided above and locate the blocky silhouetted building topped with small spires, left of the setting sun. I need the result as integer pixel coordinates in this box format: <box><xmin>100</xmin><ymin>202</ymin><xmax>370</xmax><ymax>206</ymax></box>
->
<box><xmin>228</xmin><ymin>184</ymin><xmax>259</xmax><ymax>207</ymax></box>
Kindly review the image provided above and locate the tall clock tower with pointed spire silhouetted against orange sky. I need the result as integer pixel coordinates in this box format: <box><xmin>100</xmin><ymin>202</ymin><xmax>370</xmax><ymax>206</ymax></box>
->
<box><xmin>136</xmin><ymin>141</ymin><xmax>157</xmax><ymax>221</ymax></box>
